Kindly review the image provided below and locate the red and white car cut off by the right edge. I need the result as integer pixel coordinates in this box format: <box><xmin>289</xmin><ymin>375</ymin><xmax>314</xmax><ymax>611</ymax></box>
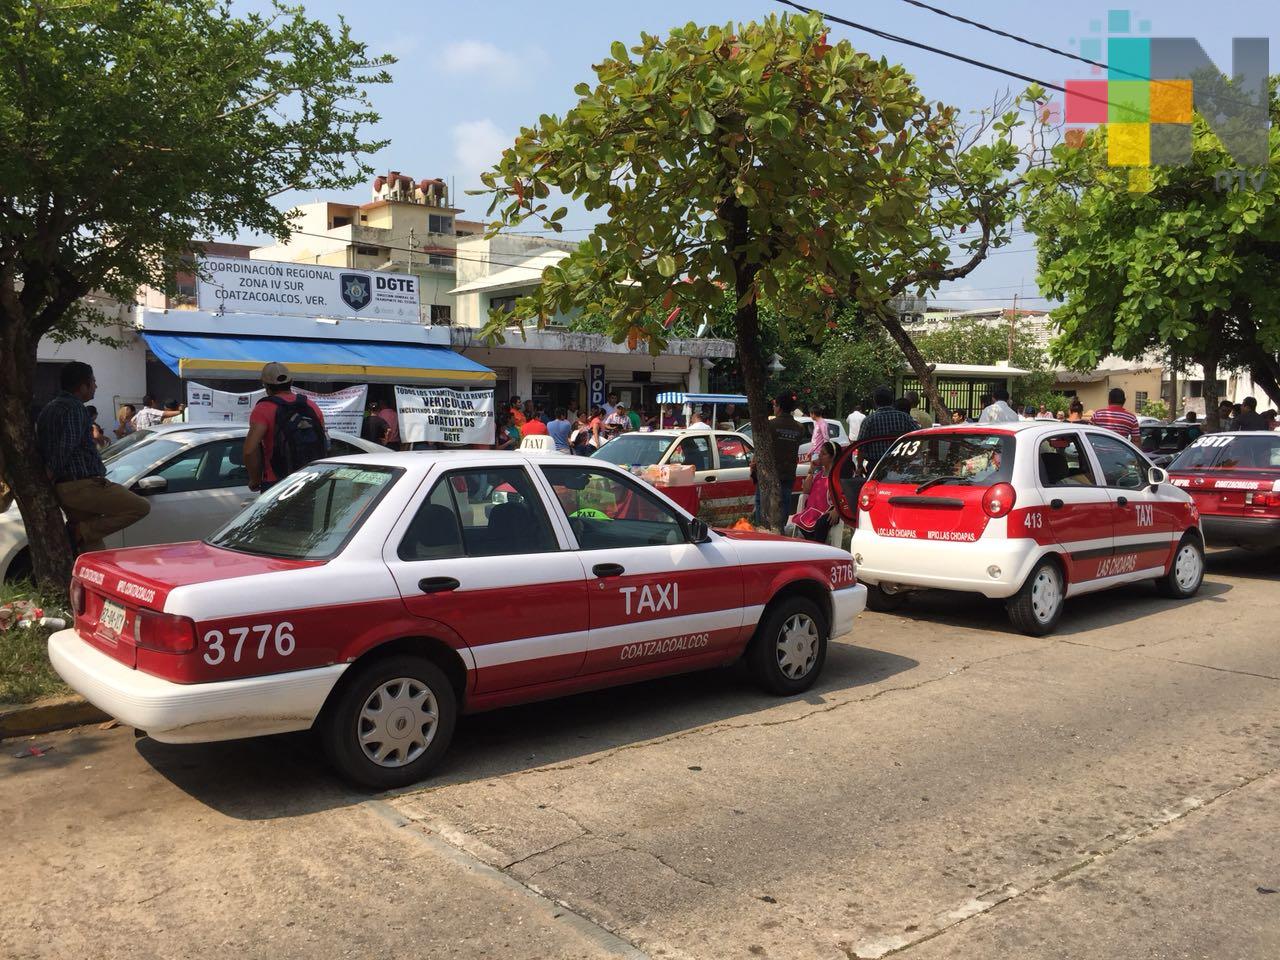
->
<box><xmin>1169</xmin><ymin>430</ymin><xmax>1280</xmax><ymax>547</ymax></box>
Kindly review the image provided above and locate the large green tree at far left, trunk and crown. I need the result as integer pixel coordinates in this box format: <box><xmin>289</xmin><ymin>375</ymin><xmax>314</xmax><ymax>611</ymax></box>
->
<box><xmin>0</xmin><ymin>0</ymin><xmax>392</xmax><ymax>582</ymax></box>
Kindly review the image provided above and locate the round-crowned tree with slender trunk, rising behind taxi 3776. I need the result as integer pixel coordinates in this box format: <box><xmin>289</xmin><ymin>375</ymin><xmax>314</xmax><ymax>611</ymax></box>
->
<box><xmin>483</xmin><ymin>15</ymin><xmax>1034</xmax><ymax>529</ymax></box>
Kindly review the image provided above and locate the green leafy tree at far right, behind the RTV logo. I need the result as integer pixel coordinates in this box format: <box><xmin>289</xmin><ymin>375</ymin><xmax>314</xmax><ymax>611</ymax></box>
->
<box><xmin>1027</xmin><ymin>79</ymin><xmax>1280</xmax><ymax>430</ymax></box>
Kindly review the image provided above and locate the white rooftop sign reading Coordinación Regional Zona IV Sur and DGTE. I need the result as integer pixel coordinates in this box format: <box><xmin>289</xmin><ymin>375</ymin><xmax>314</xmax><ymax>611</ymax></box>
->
<box><xmin>196</xmin><ymin>257</ymin><xmax>420</xmax><ymax>324</ymax></box>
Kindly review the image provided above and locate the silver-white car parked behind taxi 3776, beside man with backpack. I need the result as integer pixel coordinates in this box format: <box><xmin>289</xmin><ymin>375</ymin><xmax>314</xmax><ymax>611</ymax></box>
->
<box><xmin>0</xmin><ymin>424</ymin><xmax>385</xmax><ymax>582</ymax></box>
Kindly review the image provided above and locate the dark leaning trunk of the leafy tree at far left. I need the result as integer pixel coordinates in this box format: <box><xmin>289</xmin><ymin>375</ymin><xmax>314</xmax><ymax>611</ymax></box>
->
<box><xmin>0</xmin><ymin>315</ymin><xmax>73</xmax><ymax>590</ymax></box>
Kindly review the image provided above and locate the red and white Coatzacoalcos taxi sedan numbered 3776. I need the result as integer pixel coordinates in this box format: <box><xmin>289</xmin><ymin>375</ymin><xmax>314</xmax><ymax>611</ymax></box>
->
<box><xmin>49</xmin><ymin>452</ymin><xmax>867</xmax><ymax>788</ymax></box>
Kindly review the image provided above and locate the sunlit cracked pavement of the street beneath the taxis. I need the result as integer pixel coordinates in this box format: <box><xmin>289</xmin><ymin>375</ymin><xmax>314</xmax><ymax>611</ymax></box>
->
<box><xmin>0</xmin><ymin>553</ymin><xmax>1280</xmax><ymax>960</ymax></box>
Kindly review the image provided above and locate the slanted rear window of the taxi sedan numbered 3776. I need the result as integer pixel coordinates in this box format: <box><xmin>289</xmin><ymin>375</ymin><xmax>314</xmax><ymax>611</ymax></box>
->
<box><xmin>209</xmin><ymin>463</ymin><xmax>403</xmax><ymax>559</ymax></box>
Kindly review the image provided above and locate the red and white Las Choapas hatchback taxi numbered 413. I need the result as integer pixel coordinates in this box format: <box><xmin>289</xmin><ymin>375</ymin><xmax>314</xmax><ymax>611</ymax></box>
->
<box><xmin>833</xmin><ymin>421</ymin><xmax>1204</xmax><ymax>635</ymax></box>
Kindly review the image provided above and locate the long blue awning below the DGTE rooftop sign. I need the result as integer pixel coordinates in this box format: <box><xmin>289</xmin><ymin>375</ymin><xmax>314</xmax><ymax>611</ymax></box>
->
<box><xmin>142</xmin><ymin>332</ymin><xmax>495</xmax><ymax>387</ymax></box>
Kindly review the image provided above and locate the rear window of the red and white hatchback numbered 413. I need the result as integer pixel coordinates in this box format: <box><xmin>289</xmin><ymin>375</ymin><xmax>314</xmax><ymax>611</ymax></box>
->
<box><xmin>872</xmin><ymin>433</ymin><xmax>1014</xmax><ymax>486</ymax></box>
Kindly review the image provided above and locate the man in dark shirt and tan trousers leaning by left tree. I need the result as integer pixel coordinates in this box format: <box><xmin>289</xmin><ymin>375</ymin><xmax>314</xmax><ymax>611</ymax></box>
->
<box><xmin>36</xmin><ymin>360</ymin><xmax>151</xmax><ymax>553</ymax></box>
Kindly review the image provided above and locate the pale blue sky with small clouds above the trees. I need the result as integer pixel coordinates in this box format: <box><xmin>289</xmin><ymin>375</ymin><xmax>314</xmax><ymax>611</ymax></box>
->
<box><xmin>236</xmin><ymin>0</ymin><xmax>1280</xmax><ymax>308</ymax></box>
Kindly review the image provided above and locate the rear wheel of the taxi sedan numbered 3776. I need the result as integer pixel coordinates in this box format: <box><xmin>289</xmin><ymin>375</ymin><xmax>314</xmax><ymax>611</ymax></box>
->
<box><xmin>320</xmin><ymin>655</ymin><xmax>458</xmax><ymax>790</ymax></box>
